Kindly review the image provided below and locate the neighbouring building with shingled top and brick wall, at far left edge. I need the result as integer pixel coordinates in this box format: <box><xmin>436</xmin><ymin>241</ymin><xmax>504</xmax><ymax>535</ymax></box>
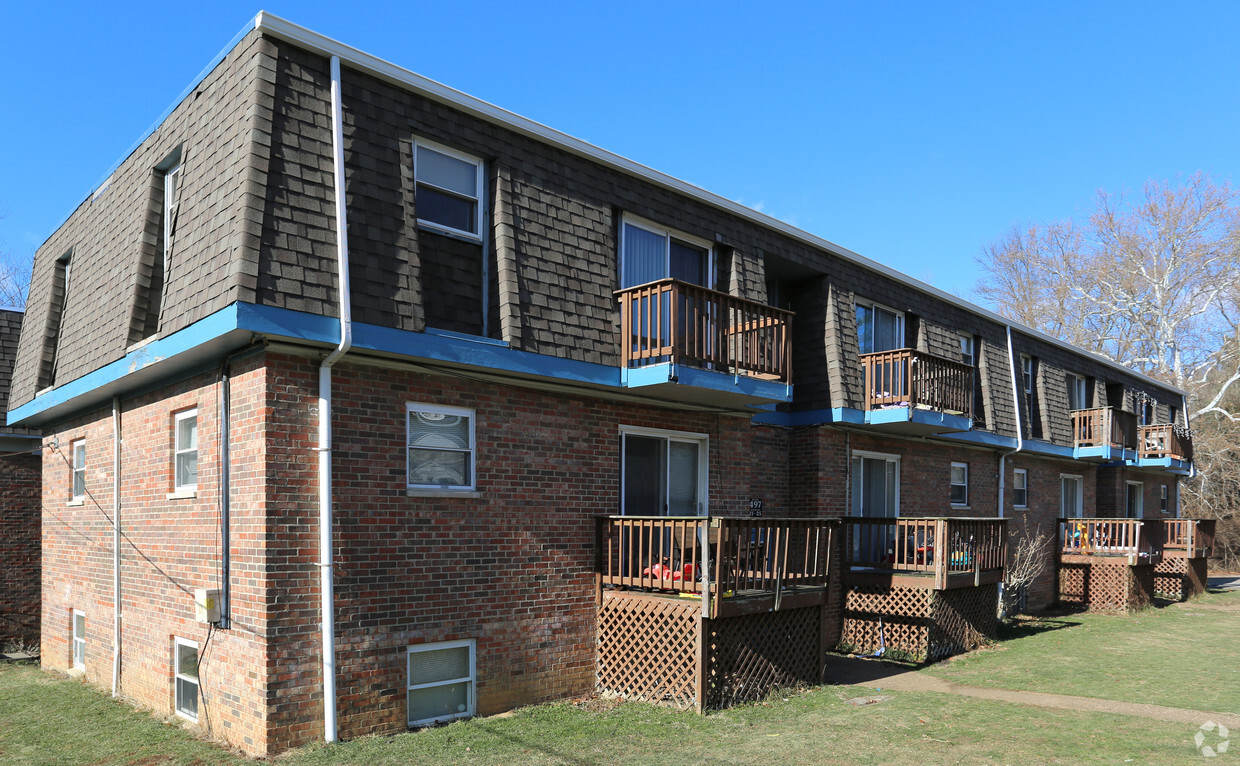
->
<box><xmin>0</xmin><ymin>303</ymin><xmax>42</xmax><ymax>649</ymax></box>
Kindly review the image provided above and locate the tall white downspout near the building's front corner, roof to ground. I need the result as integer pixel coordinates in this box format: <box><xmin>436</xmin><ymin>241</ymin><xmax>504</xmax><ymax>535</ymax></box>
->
<box><xmin>317</xmin><ymin>56</ymin><xmax>353</xmax><ymax>742</ymax></box>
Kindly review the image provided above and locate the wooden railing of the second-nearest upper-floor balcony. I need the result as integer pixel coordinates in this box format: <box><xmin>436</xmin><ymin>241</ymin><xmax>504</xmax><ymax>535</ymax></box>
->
<box><xmin>861</xmin><ymin>348</ymin><xmax>973</xmax><ymax>418</ymax></box>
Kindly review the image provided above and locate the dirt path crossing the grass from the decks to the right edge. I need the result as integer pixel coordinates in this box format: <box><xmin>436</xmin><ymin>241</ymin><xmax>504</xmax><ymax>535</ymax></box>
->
<box><xmin>827</xmin><ymin>657</ymin><xmax>1240</xmax><ymax>729</ymax></box>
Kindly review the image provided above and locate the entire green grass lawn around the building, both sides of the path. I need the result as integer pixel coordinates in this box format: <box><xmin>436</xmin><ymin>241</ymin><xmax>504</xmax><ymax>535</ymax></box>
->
<box><xmin>0</xmin><ymin>592</ymin><xmax>1240</xmax><ymax>766</ymax></box>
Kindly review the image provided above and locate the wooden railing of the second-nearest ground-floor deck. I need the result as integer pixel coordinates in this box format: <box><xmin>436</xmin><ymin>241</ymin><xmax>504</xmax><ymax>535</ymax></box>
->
<box><xmin>843</xmin><ymin>517</ymin><xmax>1007</xmax><ymax>589</ymax></box>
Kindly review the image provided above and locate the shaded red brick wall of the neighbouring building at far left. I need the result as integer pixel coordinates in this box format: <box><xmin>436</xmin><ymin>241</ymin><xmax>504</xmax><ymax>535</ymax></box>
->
<box><xmin>0</xmin><ymin>451</ymin><xmax>42</xmax><ymax>648</ymax></box>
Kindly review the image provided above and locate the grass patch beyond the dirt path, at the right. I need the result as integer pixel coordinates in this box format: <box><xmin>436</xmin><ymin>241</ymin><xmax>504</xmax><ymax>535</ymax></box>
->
<box><xmin>924</xmin><ymin>591</ymin><xmax>1240</xmax><ymax>714</ymax></box>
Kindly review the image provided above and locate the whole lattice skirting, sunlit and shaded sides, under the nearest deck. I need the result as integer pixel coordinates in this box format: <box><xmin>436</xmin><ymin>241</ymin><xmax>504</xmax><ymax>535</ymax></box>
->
<box><xmin>598</xmin><ymin>596</ymin><xmax>822</xmax><ymax>708</ymax></box>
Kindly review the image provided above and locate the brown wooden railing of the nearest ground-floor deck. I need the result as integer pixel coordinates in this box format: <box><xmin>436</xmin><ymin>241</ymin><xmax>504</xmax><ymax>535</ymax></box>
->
<box><xmin>598</xmin><ymin>516</ymin><xmax>837</xmax><ymax>595</ymax></box>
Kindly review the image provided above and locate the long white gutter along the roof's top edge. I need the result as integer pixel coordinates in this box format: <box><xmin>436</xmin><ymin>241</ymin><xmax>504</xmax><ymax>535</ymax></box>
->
<box><xmin>254</xmin><ymin>11</ymin><xmax>1184</xmax><ymax>394</ymax></box>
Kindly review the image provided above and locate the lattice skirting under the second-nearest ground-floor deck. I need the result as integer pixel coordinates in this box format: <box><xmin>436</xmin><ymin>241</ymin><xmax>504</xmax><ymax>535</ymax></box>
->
<box><xmin>839</xmin><ymin>584</ymin><xmax>999</xmax><ymax>662</ymax></box>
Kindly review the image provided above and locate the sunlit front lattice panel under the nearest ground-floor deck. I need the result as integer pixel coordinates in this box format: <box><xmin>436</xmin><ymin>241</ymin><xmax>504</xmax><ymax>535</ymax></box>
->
<box><xmin>598</xmin><ymin>599</ymin><xmax>702</xmax><ymax>708</ymax></box>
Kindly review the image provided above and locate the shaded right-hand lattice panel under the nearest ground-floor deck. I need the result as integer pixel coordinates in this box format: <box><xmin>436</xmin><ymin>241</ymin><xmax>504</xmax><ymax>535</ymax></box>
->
<box><xmin>704</xmin><ymin>606</ymin><xmax>822</xmax><ymax>708</ymax></box>
